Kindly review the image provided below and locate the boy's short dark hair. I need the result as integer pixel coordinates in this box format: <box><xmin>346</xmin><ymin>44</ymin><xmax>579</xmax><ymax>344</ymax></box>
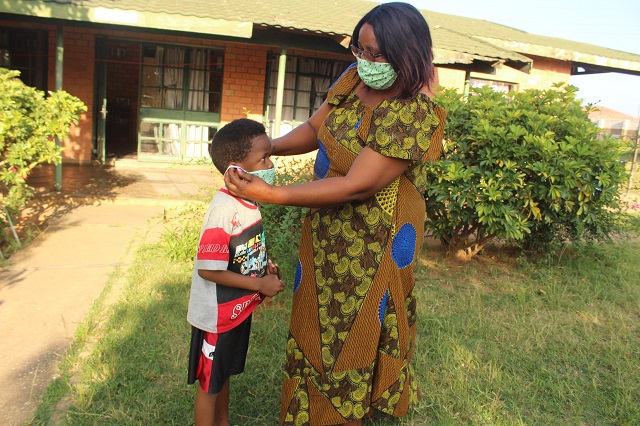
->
<box><xmin>209</xmin><ymin>118</ymin><xmax>266</xmax><ymax>173</ymax></box>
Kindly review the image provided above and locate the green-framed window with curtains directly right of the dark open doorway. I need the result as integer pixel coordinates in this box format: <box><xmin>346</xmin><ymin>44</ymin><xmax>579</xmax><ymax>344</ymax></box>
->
<box><xmin>139</xmin><ymin>45</ymin><xmax>224</xmax><ymax>159</ymax></box>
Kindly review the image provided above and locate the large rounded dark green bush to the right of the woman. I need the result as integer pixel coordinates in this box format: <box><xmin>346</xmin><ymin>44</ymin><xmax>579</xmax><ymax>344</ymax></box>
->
<box><xmin>425</xmin><ymin>84</ymin><xmax>627</xmax><ymax>257</ymax></box>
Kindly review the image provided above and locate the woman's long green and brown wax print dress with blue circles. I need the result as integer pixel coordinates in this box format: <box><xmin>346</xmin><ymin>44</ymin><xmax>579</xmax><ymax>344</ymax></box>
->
<box><xmin>280</xmin><ymin>67</ymin><xmax>446</xmax><ymax>425</ymax></box>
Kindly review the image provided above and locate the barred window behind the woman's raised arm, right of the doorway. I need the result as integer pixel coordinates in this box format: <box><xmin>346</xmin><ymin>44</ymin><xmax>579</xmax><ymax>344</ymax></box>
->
<box><xmin>264</xmin><ymin>53</ymin><xmax>351</xmax><ymax>137</ymax></box>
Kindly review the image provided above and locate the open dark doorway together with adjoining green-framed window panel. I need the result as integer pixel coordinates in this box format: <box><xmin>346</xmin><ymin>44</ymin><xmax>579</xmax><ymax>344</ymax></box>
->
<box><xmin>95</xmin><ymin>39</ymin><xmax>224</xmax><ymax>162</ymax></box>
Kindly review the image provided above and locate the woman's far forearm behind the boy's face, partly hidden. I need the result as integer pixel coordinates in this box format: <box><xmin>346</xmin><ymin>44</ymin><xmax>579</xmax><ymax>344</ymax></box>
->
<box><xmin>271</xmin><ymin>101</ymin><xmax>331</xmax><ymax>155</ymax></box>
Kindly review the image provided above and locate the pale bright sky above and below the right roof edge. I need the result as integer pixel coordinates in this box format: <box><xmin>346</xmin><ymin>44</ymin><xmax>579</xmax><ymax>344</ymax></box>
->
<box><xmin>380</xmin><ymin>0</ymin><xmax>640</xmax><ymax>117</ymax></box>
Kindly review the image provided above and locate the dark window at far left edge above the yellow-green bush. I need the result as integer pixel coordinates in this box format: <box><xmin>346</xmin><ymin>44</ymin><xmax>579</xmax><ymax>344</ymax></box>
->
<box><xmin>0</xmin><ymin>28</ymin><xmax>47</xmax><ymax>91</ymax></box>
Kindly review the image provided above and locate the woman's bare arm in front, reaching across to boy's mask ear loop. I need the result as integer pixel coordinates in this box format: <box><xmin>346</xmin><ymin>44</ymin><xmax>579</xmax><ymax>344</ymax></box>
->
<box><xmin>225</xmin><ymin>147</ymin><xmax>410</xmax><ymax>208</ymax></box>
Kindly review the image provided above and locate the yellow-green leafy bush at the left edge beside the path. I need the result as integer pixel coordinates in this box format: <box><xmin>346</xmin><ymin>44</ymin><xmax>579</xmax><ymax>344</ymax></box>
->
<box><xmin>0</xmin><ymin>68</ymin><xmax>87</xmax><ymax>213</ymax></box>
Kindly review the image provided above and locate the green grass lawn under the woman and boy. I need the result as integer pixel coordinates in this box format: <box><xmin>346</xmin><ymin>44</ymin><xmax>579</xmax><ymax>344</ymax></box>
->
<box><xmin>30</xmin><ymin>225</ymin><xmax>640</xmax><ymax>425</ymax></box>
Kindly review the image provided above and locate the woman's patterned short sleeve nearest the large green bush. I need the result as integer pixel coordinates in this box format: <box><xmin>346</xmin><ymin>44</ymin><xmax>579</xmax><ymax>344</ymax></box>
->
<box><xmin>366</xmin><ymin>94</ymin><xmax>446</xmax><ymax>161</ymax></box>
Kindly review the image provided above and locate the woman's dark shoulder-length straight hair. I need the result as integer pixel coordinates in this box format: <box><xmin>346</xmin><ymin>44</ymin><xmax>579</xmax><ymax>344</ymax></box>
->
<box><xmin>351</xmin><ymin>2</ymin><xmax>435</xmax><ymax>98</ymax></box>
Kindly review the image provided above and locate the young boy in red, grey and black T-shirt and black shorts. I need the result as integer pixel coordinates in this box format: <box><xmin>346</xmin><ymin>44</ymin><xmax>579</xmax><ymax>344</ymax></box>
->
<box><xmin>187</xmin><ymin>119</ymin><xmax>284</xmax><ymax>426</ymax></box>
